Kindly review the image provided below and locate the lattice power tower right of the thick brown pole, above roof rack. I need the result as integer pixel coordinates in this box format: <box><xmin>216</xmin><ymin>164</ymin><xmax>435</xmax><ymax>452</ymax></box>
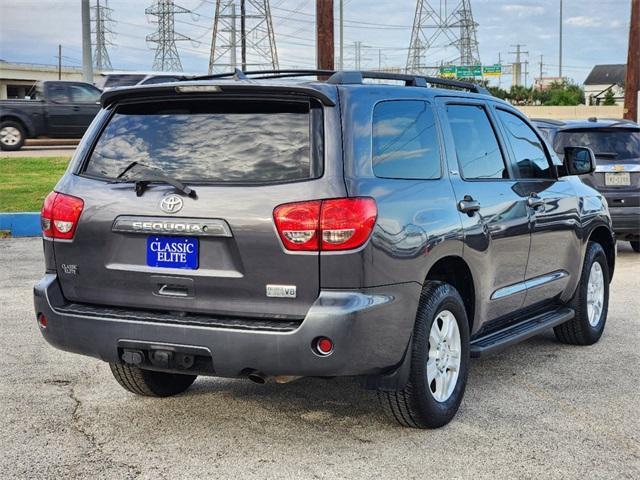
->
<box><xmin>406</xmin><ymin>0</ymin><xmax>480</xmax><ymax>74</ymax></box>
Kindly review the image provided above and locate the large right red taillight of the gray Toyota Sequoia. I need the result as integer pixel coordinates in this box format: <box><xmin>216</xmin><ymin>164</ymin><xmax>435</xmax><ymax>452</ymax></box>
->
<box><xmin>273</xmin><ymin>197</ymin><xmax>378</xmax><ymax>251</ymax></box>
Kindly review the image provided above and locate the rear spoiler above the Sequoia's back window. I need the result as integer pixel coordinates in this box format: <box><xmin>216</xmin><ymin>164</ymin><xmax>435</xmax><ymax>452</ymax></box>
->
<box><xmin>100</xmin><ymin>81</ymin><xmax>336</xmax><ymax>108</ymax></box>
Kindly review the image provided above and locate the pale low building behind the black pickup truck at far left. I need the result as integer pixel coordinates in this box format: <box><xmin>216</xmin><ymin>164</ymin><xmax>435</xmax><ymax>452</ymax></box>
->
<box><xmin>0</xmin><ymin>60</ymin><xmax>82</xmax><ymax>100</ymax></box>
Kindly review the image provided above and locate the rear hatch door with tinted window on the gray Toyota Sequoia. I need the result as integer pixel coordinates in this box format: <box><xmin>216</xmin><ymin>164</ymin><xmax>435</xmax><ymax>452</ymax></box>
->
<box><xmin>55</xmin><ymin>90</ymin><xmax>344</xmax><ymax>318</ymax></box>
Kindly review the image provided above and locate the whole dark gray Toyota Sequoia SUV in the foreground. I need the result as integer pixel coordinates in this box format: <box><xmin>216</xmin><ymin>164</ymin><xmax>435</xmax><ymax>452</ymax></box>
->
<box><xmin>34</xmin><ymin>72</ymin><xmax>615</xmax><ymax>428</ymax></box>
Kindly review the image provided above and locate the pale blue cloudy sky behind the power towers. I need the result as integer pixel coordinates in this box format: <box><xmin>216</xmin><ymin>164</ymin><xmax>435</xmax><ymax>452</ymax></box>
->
<box><xmin>0</xmin><ymin>0</ymin><xmax>631</xmax><ymax>86</ymax></box>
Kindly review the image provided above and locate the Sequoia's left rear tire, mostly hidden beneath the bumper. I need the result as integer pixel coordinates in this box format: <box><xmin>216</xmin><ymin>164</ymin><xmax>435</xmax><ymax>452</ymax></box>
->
<box><xmin>109</xmin><ymin>363</ymin><xmax>197</xmax><ymax>397</ymax></box>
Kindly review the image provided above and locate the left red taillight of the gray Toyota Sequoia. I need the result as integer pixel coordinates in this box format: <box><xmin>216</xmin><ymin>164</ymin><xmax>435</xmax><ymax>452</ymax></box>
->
<box><xmin>40</xmin><ymin>192</ymin><xmax>84</xmax><ymax>240</ymax></box>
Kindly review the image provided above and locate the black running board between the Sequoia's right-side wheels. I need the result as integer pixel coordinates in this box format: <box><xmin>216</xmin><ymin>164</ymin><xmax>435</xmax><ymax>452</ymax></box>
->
<box><xmin>471</xmin><ymin>307</ymin><xmax>575</xmax><ymax>358</ymax></box>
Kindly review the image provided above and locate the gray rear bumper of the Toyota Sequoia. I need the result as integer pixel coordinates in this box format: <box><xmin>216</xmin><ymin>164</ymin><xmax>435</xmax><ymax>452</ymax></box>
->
<box><xmin>34</xmin><ymin>274</ymin><xmax>421</xmax><ymax>377</ymax></box>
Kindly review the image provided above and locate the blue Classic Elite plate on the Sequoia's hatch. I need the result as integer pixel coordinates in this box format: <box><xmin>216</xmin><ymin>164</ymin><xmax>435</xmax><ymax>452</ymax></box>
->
<box><xmin>147</xmin><ymin>237</ymin><xmax>198</xmax><ymax>270</ymax></box>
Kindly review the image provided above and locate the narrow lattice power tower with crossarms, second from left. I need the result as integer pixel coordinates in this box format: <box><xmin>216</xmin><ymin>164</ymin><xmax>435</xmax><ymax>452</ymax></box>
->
<box><xmin>144</xmin><ymin>0</ymin><xmax>191</xmax><ymax>72</ymax></box>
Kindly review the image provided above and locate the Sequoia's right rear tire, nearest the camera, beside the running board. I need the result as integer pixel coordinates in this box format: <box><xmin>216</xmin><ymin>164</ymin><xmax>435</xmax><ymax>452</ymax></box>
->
<box><xmin>378</xmin><ymin>281</ymin><xmax>469</xmax><ymax>428</ymax></box>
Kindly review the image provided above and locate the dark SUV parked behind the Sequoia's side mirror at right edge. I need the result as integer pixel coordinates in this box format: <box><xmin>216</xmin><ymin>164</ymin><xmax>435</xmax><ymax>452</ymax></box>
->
<box><xmin>533</xmin><ymin>118</ymin><xmax>640</xmax><ymax>253</ymax></box>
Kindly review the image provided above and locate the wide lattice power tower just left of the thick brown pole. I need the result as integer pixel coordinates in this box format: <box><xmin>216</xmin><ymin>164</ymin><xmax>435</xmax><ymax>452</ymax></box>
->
<box><xmin>209</xmin><ymin>0</ymin><xmax>280</xmax><ymax>74</ymax></box>
